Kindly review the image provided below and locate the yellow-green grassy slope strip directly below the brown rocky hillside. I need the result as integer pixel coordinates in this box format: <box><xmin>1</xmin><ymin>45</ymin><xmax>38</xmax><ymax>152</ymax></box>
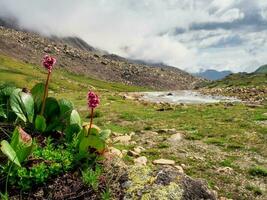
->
<box><xmin>0</xmin><ymin>55</ymin><xmax>149</xmax><ymax>92</ymax></box>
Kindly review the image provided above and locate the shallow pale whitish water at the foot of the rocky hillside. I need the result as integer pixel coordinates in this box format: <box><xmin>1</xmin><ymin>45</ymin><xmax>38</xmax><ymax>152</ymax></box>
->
<box><xmin>140</xmin><ymin>90</ymin><xmax>240</xmax><ymax>104</ymax></box>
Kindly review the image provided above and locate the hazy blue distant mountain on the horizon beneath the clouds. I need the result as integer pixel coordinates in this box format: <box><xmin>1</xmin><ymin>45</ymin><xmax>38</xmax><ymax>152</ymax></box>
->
<box><xmin>193</xmin><ymin>69</ymin><xmax>233</xmax><ymax>80</ymax></box>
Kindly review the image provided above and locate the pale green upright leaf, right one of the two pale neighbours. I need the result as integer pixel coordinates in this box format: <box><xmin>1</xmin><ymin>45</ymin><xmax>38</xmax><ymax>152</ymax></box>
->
<box><xmin>19</xmin><ymin>92</ymin><xmax>34</xmax><ymax>123</ymax></box>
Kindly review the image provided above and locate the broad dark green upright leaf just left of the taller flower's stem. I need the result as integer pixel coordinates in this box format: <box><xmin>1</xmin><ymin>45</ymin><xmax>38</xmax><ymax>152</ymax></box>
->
<box><xmin>31</xmin><ymin>83</ymin><xmax>45</xmax><ymax>113</ymax></box>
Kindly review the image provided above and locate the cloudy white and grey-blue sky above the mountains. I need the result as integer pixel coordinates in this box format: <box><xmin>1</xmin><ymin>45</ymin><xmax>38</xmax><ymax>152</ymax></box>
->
<box><xmin>0</xmin><ymin>0</ymin><xmax>267</xmax><ymax>72</ymax></box>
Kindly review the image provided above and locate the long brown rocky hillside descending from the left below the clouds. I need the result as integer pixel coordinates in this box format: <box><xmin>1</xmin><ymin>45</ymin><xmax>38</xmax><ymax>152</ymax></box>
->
<box><xmin>0</xmin><ymin>27</ymin><xmax>201</xmax><ymax>90</ymax></box>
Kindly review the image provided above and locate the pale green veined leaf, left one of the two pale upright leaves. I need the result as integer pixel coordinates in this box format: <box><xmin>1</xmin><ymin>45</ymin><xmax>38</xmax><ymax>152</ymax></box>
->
<box><xmin>10</xmin><ymin>89</ymin><xmax>27</xmax><ymax>123</ymax></box>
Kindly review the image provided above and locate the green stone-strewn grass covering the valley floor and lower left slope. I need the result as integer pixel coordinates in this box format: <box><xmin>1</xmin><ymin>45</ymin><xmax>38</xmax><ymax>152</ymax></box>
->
<box><xmin>0</xmin><ymin>56</ymin><xmax>267</xmax><ymax>199</ymax></box>
